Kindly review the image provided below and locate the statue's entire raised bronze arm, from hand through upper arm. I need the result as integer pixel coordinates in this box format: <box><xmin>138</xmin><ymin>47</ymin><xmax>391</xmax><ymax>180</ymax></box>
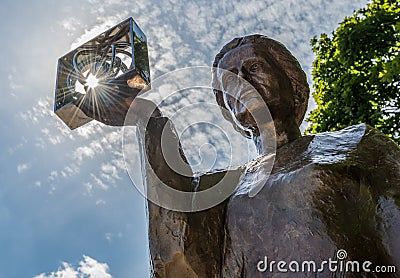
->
<box><xmin>77</xmin><ymin>90</ymin><xmax>237</xmax><ymax>278</ymax></box>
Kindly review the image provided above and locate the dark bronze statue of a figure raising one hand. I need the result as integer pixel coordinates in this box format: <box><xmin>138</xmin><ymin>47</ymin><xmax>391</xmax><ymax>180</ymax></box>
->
<box><xmin>73</xmin><ymin>35</ymin><xmax>400</xmax><ymax>278</ymax></box>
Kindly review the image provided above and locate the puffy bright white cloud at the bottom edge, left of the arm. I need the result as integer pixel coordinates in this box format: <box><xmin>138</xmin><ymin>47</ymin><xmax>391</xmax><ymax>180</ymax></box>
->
<box><xmin>34</xmin><ymin>255</ymin><xmax>112</xmax><ymax>278</ymax></box>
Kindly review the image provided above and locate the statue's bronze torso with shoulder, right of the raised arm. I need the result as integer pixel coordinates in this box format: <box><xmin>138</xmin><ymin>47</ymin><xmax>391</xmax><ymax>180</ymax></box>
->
<box><xmin>222</xmin><ymin>125</ymin><xmax>400</xmax><ymax>277</ymax></box>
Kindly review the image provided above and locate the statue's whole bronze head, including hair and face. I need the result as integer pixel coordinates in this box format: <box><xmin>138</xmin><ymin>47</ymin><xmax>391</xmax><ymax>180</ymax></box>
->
<box><xmin>213</xmin><ymin>34</ymin><xmax>310</xmax><ymax>137</ymax></box>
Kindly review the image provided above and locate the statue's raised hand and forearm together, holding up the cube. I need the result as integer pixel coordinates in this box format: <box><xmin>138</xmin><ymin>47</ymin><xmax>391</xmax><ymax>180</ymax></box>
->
<box><xmin>72</xmin><ymin>90</ymin><xmax>196</xmax><ymax>277</ymax></box>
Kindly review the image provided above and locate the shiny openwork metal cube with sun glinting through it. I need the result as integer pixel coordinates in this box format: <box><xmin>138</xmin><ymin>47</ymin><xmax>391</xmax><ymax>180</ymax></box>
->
<box><xmin>54</xmin><ymin>18</ymin><xmax>150</xmax><ymax>129</ymax></box>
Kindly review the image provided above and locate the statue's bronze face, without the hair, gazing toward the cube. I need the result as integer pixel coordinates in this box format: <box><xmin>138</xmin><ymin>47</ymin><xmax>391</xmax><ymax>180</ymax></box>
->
<box><xmin>217</xmin><ymin>44</ymin><xmax>294</xmax><ymax>129</ymax></box>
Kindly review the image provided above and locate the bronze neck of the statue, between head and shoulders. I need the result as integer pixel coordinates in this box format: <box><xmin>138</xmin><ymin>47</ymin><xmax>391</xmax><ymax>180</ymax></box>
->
<box><xmin>253</xmin><ymin>115</ymin><xmax>301</xmax><ymax>155</ymax></box>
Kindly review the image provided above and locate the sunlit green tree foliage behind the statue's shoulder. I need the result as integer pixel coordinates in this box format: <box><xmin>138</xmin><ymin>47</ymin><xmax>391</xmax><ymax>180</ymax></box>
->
<box><xmin>307</xmin><ymin>0</ymin><xmax>400</xmax><ymax>143</ymax></box>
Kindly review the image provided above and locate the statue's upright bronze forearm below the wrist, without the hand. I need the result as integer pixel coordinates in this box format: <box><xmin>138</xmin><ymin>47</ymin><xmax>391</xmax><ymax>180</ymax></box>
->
<box><xmin>137</xmin><ymin>115</ymin><xmax>195</xmax><ymax>277</ymax></box>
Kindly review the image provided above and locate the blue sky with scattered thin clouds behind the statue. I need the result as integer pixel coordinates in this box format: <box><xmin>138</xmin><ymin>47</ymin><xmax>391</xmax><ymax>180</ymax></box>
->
<box><xmin>0</xmin><ymin>0</ymin><xmax>367</xmax><ymax>278</ymax></box>
